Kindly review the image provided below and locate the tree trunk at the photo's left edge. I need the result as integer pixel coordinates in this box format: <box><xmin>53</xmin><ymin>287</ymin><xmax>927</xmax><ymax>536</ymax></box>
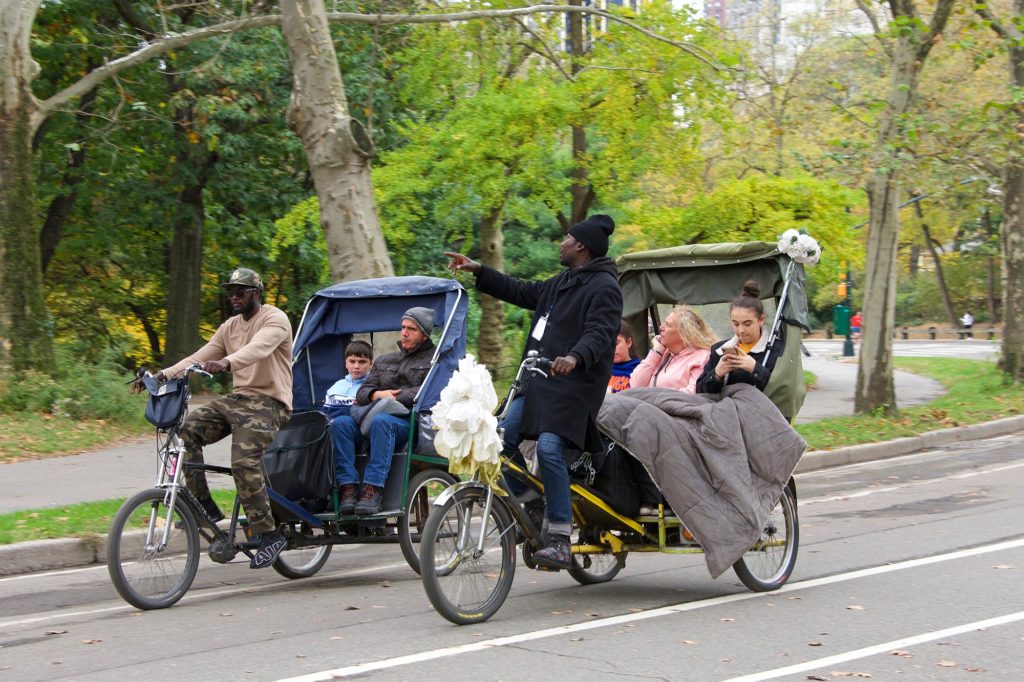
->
<box><xmin>0</xmin><ymin>0</ymin><xmax>53</xmax><ymax>372</ymax></box>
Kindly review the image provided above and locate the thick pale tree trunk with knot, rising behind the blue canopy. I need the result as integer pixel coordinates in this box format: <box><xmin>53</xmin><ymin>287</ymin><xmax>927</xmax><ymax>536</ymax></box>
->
<box><xmin>281</xmin><ymin>0</ymin><xmax>394</xmax><ymax>282</ymax></box>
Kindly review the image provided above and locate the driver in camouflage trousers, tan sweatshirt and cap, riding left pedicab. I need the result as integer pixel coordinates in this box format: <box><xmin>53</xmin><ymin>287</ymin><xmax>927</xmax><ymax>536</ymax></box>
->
<box><xmin>144</xmin><ymin>267</ymin><xmax>292</xmax><ymax>568</ymax></box>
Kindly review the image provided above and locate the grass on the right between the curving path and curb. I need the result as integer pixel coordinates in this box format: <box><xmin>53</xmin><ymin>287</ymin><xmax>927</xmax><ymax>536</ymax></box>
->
<box><xmin>796</xmin><ymin>357</ymin><xmax>1024</xmax><ymax>450</ymax></box>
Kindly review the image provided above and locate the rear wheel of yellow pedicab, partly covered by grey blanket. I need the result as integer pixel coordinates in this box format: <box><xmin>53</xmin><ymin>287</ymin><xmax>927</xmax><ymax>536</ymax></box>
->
<box><xmin>732</xmin><ymin>486</ymin><xmax>800</xmax><ymax>592</ymax></box>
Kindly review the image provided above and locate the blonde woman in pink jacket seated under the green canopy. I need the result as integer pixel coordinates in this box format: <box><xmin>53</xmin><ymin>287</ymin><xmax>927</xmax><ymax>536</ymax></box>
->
<box><xmin>630</xmin><ymin>305</ymin><xmax>715</xmax><ymax>393</ymax></box>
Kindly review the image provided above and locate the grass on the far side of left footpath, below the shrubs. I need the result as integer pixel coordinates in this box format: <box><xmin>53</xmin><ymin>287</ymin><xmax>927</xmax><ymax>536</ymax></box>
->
<box><xmin>0</xmin><ymin>413</ymin><xmax>153</xmax><ymax>463</ymax></box>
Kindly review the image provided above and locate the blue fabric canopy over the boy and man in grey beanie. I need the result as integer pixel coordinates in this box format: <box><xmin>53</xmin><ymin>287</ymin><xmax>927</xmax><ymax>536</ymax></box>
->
<box><xmin>292</xmin><ymin>276</ymin><xmax>469</xmax><ymax>411</ymax></box>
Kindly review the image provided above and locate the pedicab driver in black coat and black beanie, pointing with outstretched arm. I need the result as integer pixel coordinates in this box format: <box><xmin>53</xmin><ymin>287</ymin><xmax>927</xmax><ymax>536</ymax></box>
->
<box><xmin>445</xmin><ymin>215</ymin><xmax>623</xmax><ymax>568</ymax></box>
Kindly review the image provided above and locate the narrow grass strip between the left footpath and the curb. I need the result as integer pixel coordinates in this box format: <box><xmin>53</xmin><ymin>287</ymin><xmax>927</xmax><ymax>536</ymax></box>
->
<box><xmin>0</xmin><ymin>487</ymin><xmax>234</xmax><ymax>545</ymax></box>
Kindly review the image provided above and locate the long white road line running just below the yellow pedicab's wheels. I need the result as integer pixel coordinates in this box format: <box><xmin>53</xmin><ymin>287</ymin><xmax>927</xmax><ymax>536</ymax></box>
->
<box><xmin>278</xmin><ymin>538</ymin><xmax>1024</xmax><ymax>682</ymax></box>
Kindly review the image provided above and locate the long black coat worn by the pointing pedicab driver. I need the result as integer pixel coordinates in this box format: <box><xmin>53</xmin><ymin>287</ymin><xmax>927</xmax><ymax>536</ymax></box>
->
<box><xmin>476</xmin><ymin>257</ymin><xmax>623</xmax><ymax>452</ymax></box>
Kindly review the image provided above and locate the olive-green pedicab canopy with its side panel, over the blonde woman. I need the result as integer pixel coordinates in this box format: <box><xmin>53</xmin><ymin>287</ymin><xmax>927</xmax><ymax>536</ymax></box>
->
<box><xmin>615</xmin><ymin>242</ymin><xmax>809</xmax><ymax>419</ymax></box>
